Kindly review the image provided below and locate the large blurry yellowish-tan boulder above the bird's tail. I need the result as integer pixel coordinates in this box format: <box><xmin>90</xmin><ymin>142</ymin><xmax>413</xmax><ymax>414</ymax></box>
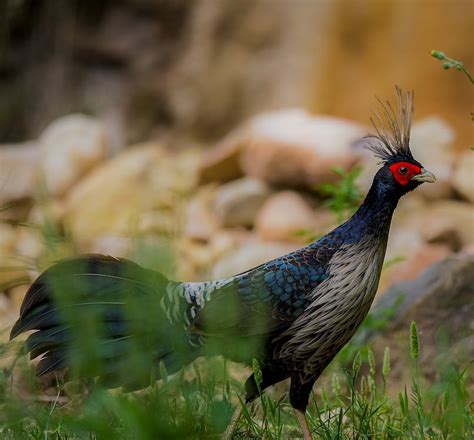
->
<box><xmin>64</xmin><ymin>143</ymin><xmax>197</xmax><ymax>251</ymax></box>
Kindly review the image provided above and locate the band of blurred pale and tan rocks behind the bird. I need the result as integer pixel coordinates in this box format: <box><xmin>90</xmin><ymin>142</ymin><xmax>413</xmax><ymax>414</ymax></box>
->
<box><xmin>0</xmin><ymin>108</ymin><xmax>474</xmax><ymax>378</ymax></box>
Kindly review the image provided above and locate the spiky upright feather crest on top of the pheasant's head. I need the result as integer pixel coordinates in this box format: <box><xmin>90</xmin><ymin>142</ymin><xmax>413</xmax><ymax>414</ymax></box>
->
<box><xmin>365</xmin><ymin>86</ymin><xmax>414</xmax><ymax>162</ymax></box>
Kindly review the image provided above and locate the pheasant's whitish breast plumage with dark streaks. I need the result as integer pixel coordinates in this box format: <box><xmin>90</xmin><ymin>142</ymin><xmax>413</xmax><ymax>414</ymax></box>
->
<box><xmin>279</xmin><ymin>240</ymin><xmax>385</xmax><ymax>375</ymax></box>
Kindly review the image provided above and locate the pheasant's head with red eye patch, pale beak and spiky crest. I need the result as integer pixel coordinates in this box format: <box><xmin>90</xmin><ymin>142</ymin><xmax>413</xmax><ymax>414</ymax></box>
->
<box><xmin>366</xmin><ymin>87</ymin><xmax>436</xmax><ymax>196</ymax></box>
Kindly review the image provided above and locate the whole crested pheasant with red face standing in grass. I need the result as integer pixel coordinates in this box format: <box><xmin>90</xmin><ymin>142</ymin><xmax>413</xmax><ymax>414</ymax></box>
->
<box><xmin>10</xmin><ymin>86</ymin><xmax>436</xmax><ymax>440</ymax></box>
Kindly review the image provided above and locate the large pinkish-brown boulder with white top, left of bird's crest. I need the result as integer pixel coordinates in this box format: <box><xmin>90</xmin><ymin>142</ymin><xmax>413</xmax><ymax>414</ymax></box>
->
<box><xmin>200</xmin><ymin>108</ymin><xmax>367</xmax><ymax>188</ymax></box>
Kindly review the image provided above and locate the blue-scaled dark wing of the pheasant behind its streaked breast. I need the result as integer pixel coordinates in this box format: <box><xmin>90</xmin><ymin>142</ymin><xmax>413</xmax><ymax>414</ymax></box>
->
<box><xmin>190</xmin><ymin>242</ymin><xmax>332</xmax><ymax>337</ymax></box>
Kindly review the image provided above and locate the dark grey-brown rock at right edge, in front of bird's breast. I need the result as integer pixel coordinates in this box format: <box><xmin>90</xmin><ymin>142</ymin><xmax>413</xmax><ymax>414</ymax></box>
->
<box><xmin>365</xmin><ymin>254</ymin><xmax>474</xmax><ymax>383</ymax></box>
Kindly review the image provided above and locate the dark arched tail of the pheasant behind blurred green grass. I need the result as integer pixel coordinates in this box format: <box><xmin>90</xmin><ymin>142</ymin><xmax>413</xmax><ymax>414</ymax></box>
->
<box><xmin>10</xmin><ymin>255</ymin><xmax>192</xmax><ymax>390</ymax></box>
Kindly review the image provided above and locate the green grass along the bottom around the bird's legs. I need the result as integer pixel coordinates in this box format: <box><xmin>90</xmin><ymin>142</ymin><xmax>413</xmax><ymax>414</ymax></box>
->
<box><xmin>0</xmin><ymin>323</ymin><xmax>474</xmax><ymax>439</ymax></box>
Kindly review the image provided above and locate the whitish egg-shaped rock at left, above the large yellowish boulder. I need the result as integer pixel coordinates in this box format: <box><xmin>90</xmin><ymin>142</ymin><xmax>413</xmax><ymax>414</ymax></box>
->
<box><xmin>39</xmin><ymin>114</ymin><xmax>107</xmax><ymax>196</ymax></box>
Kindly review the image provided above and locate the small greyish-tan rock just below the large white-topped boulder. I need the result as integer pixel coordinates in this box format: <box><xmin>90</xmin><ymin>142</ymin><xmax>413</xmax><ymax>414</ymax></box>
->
<box><xmin>213</xmin><ymin>177</ymin><xmax>270</xmax><ymax>227</ymax></box>
